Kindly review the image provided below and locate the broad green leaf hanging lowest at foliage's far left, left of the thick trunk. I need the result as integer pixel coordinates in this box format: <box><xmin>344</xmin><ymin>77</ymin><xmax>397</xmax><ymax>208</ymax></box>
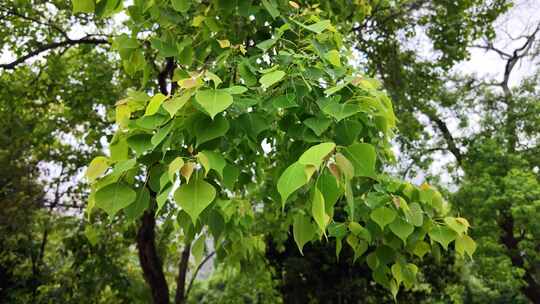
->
<box><xmin>94</xmin><ymin>183</ymin><xmax>137</xmax><ymax>218</ymax></box>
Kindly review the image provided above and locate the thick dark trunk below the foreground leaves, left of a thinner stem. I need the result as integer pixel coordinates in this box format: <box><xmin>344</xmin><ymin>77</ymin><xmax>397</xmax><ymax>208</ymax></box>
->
<box><xmin>137</xmin><ymin>210</ymin><xmax>169</xmax><ymax>304</ymax></box>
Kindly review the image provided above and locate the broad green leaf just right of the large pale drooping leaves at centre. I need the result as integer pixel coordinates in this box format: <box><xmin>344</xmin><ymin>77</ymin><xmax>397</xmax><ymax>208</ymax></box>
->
<box><xmin>343</xmin><ymin>143</ymin><xmax>377</xmax><ymax>177</ymax></box>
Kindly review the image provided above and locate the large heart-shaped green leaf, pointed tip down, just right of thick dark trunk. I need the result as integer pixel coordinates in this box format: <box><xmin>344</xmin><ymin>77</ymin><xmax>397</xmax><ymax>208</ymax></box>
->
<box><xmin>174</xmin><ymin>178</ymin><xmax>216</xmax><ymax>225</ymax></box>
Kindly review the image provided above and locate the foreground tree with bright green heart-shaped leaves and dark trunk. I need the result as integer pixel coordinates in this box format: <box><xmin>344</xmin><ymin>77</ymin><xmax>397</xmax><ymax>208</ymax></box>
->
<box><xmin>77</xmin><ymin>0</ymin><xmax>475</xmax><ymax>303</ymax></box>
